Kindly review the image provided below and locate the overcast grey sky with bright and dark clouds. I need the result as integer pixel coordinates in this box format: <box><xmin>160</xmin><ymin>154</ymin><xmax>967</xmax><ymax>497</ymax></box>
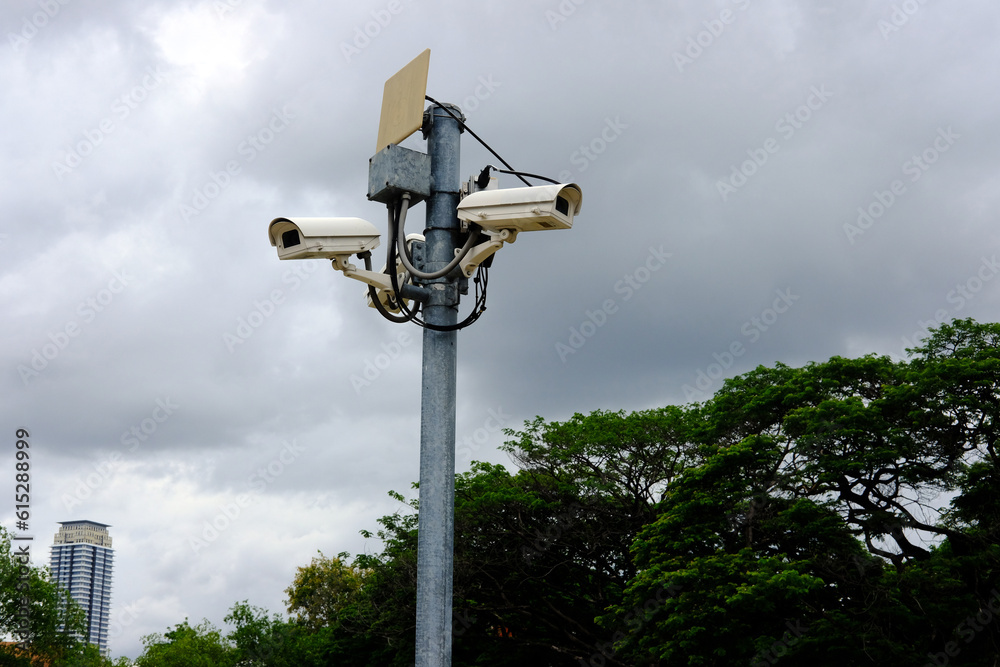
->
<box><xmin>0</xmin><ymin>0</ymin><xmax>1000</xmax><ymax>656</ymax></box>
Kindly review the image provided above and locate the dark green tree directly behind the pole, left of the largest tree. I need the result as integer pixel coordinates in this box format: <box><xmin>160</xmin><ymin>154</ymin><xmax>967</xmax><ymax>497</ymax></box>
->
<box><xmin>343</xmin><ymin>408</ymin><xmax>697</xmax><ymax>665</ymax></box>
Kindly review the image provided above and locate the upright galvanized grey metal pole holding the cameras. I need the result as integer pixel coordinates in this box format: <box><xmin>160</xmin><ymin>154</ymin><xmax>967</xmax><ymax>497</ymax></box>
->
<box><xmin>415</xmin><ymin>100</ymin><xmax>462</xmax><ymax>667</ymax></box>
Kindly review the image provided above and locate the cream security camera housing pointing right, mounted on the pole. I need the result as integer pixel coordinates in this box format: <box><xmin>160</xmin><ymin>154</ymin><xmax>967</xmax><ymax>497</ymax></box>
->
<box><xmin>458</xmin><ymin>183</ymin><xmax>583</xmax><ymax>232</ymax></box>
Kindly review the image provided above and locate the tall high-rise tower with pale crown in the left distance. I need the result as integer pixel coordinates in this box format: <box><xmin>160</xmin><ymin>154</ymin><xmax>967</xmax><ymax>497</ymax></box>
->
<box><xmin>49</xmin><ymin>521</ymin><xmax>114</xmax><ymax>655</ymax></box>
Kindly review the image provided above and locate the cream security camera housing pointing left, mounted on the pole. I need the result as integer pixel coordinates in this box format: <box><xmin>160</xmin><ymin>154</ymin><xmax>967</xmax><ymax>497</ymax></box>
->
<box><xmin>267</xmin><ymin>218</ymin><xmax>379</xmax><ymax>259</ymax></box>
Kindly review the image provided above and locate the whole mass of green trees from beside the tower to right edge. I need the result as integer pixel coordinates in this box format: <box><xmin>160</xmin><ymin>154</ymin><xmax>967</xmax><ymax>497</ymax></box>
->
<box><xmin>129</xmin><ymin>320</ymin><xmax>1000</xmax><ymax>667</ymax></box>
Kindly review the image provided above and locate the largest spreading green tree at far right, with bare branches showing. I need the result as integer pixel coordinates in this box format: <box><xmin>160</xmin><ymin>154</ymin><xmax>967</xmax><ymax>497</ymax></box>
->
<box><xmin>602</xmin><ymin>320</ymin><xmax>1000</xmax><ymax>665</ymax></box>
